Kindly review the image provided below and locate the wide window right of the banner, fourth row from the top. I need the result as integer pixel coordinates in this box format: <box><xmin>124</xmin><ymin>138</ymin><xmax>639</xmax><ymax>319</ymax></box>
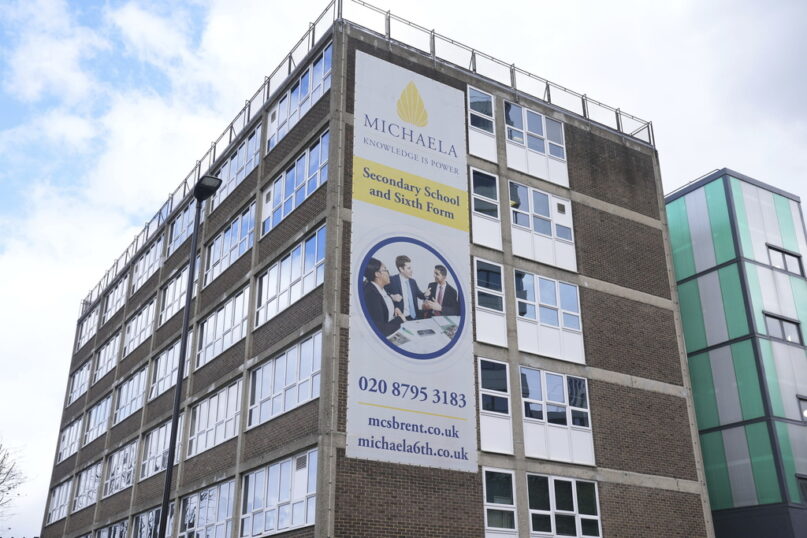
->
<box><xmin>520</xmin><ymin>366</ymin><xmax>591</xmax><ymax>428</ymax></box>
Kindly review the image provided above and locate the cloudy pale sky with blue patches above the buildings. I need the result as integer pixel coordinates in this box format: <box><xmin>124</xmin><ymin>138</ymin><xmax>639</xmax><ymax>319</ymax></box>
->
<box><xmin>0</xmin><ymin>0</ymin><xmax>807</xmax><ymax>538</ymax></box>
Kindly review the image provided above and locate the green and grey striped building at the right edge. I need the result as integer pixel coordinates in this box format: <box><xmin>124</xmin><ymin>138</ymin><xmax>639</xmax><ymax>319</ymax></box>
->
<box><xmin>666</xmin><ymin>168</ymin><xmax>807</xmax><ymax>537</ymax></box>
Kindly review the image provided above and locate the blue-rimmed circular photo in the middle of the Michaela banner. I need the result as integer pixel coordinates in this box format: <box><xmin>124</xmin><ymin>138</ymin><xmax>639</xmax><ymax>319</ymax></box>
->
<box><xmin>357</xmin><ymin>237</ymin><xmax>466</xmax><ymax>360</ymax></box>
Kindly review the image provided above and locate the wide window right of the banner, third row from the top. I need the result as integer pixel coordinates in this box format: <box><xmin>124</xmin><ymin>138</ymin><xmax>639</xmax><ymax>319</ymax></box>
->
<box><xmin>515</xmin><ymin>271</ymin><xmax>581</xmax><ymax>331</ymax></box>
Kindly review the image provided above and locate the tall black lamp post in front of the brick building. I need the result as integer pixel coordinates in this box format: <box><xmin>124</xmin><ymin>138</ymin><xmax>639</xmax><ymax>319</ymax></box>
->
<box><xmin>157</xmin><ymin>175</ymin><xmax>221</xmax><ymax>538</ymax></box>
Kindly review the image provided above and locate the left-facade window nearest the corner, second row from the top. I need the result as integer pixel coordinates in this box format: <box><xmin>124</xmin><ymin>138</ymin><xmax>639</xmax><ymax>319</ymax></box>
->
<box><xmin>261</xmin><ymin>132</ymin><xmax>329</xmax><ymax>234</ymax></box>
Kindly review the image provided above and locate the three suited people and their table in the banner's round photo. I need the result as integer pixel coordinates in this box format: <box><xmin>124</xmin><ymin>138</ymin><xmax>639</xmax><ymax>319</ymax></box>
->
<box><xmin>362</xmin><ymin>254</ymin><xmax>461</xmax><ymax>354</ymax></box>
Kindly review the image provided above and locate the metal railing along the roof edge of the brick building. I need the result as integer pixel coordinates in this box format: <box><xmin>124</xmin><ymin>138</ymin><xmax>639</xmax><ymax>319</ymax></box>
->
<box><xmin>79</xmin><ymin>0</ymin><xmax>655</xmax><ymax>317</ymax></box>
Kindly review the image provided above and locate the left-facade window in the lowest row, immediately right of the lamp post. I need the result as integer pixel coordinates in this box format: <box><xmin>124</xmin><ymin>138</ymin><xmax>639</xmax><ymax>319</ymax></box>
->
<box><xmin>178</xmin><ymin>480</ymin><xmax>235</xmax><ymax>538</ymax></box>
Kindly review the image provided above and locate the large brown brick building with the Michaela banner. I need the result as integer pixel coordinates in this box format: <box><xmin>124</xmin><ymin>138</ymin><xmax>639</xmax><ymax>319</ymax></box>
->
<box><xmin>42</xmin><ymin>2</ymin><xmax>711</xmax><ymax>538</ymax></box>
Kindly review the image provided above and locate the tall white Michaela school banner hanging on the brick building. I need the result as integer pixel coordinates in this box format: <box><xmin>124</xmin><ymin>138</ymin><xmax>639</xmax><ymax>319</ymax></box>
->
<box><xmin>347</xmin><ymin>52</ymin><xmax>477</xmax><ymax>472</ymax></box>
